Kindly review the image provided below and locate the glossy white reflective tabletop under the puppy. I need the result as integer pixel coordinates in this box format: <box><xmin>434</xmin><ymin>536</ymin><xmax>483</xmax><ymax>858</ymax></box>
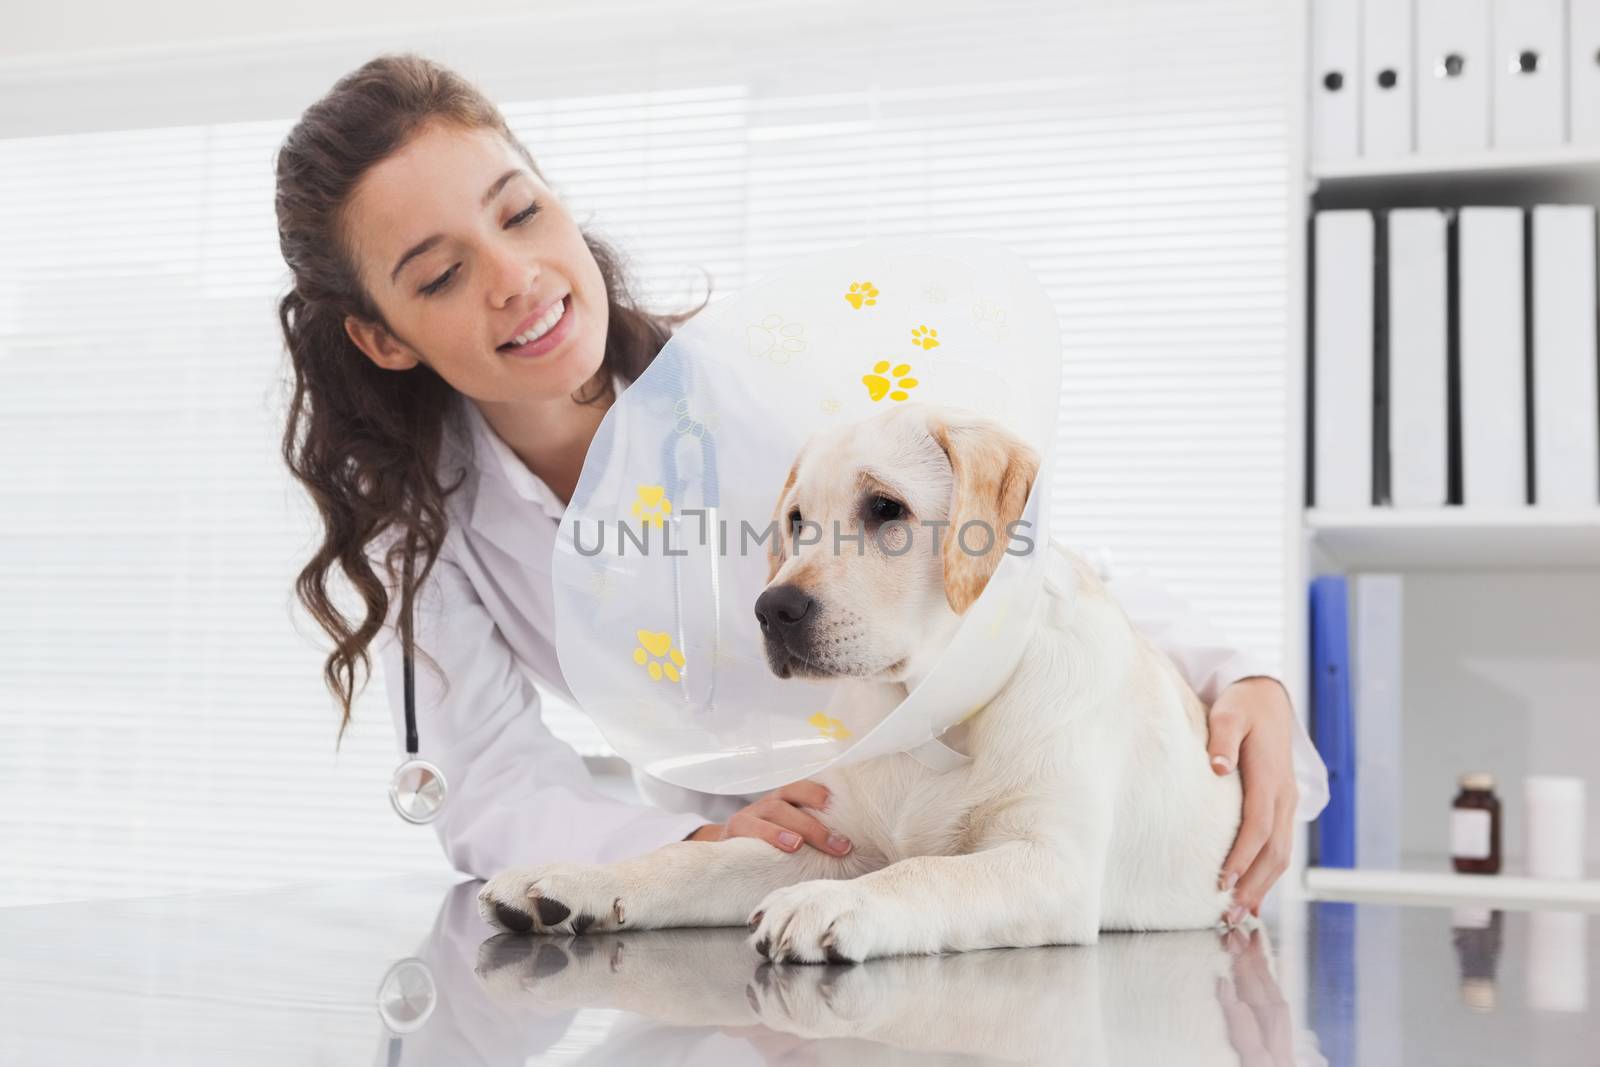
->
<box><xmin>0</xmin><ymin>877</ymin><xmax>1600</xmax><ymax>1067</ymax></box>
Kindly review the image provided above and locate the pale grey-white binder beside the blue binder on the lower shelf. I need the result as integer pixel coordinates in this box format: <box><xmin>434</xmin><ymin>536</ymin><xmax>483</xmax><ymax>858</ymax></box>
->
<box><xmin>1350</xmin><ymin>574</ymin><xmax>1405</xmax><ymax>870</ymax></box>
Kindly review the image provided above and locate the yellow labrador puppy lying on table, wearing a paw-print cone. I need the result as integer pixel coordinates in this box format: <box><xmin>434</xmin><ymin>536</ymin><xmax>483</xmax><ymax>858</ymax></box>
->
<box><xmin>478</xmin><ymin>405</ymin><xmax>1240</xmax><ymax>963</ymax></box>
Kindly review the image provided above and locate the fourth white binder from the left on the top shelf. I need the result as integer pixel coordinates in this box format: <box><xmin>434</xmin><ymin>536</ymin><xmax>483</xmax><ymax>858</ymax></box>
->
<box><xmin>1490</xmin><ymin>0</ymin><xmax>1568</xmax><ymax>149</ymax></box>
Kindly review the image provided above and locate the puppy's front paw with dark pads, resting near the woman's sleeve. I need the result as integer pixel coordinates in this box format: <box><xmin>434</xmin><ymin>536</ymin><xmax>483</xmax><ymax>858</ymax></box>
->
<box><xmin>478</xmin><ymin>864</ymin><xmax>627</xmax><ymax>934</ymax></box>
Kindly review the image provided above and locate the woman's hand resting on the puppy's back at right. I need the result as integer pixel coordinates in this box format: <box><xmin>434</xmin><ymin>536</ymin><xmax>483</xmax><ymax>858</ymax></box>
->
<box><xmin>1206</xmin><ymin>677</ymin><xmax>1299</xmax><ymax>923</ymax></box>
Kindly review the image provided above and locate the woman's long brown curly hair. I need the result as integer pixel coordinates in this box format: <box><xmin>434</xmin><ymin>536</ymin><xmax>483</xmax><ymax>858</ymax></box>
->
<box><xmin>275</xmin><ymin>54</ymin><xmax>704</xmax><ymax>739</ymax></box>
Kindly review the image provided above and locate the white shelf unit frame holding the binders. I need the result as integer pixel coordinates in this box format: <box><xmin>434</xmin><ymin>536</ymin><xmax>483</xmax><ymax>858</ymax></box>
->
<box><xmin>1282</xmin><ymin>0</ymin><xmax>1600</xmax><ymax>910</ymax></box>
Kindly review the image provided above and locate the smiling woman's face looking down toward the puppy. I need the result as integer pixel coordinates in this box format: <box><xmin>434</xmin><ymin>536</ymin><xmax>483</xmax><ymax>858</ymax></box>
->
<box><xmin>344</xmin><ymin>122</ymin><xmax>608</xmax><ymax>402</ymax></box>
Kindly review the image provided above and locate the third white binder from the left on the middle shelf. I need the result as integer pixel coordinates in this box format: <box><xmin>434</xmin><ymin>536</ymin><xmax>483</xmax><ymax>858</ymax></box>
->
<box><xmin>1458</xmin><ymin>208</ymin><xmax>1528</xmax><ymax>509</ymax></box>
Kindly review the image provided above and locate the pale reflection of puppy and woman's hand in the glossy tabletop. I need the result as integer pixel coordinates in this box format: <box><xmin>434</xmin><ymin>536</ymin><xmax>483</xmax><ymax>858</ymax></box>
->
<box><xmin>477</xmin><ymin>929</ymin><xmax>1294</xmax><ymax>1065</ymax></box>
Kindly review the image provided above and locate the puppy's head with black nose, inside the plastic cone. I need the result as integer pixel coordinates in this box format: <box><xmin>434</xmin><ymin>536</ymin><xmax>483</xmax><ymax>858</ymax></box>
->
<box><xmin>755</xmin><ymin>403</ymin><xmax>1038</xmax><ymax>681</ymax></box>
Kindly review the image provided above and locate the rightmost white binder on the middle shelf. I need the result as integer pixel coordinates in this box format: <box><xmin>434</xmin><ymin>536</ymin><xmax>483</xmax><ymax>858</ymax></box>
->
<box><xmin>1533</xmin><ymin>205</ymin><xmax>1600</xmax><ymax>507</ymax></box>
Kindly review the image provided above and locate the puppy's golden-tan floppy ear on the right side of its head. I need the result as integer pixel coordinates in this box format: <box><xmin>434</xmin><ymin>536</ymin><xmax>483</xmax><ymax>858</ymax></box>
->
<box><xmin>928</xmin><ymin>416</ymin><xmax>1038</xmax><ymax>614</ymax></box>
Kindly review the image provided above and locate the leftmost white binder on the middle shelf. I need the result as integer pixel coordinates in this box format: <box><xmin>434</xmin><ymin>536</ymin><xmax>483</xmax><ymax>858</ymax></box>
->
<box><xmin>1312</xmin><ymin>211</ymin><xmax>1373</xmax><ymax>510</ymax></box>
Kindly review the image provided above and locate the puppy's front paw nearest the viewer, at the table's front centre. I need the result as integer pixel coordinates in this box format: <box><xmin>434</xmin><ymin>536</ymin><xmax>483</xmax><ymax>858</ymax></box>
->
<box><xmin>749</xmin><ymin>880</ymin><xmax>938</xmax><ymax>963</ymax></box>
